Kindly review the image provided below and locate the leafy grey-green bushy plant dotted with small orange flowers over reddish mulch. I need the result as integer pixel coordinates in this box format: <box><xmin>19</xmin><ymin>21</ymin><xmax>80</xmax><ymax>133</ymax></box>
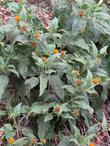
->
<box><xmin>0</xmin><ymin>0</ymin><xmax>110</xmax><ymax>146</ymax></box>
